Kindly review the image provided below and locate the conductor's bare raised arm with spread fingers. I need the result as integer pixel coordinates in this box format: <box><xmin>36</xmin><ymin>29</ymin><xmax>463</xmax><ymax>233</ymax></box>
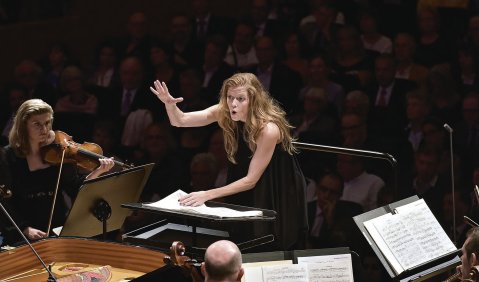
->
<box><xmin>150</xmin><ymin>80</ymin><xmax>218</xmax><ymax>127</ymax></box>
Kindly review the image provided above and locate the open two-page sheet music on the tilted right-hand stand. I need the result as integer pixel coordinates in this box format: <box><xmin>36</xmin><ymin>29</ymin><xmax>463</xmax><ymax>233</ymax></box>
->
<box><xmin>364</xmin><ymin>199</ymin><xmax>456</xmax><ymax>274</ymax></box>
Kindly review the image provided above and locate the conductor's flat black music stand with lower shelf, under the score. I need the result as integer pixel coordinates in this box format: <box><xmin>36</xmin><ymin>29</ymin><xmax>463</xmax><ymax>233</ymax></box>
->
<box><xmin>122</xmin><ymin>201</ymin><xmax>276</xmax><ymax>255</ymax></box>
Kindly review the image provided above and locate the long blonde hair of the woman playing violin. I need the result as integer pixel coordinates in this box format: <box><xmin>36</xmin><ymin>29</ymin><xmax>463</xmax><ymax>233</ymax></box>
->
<box><xmin>8</xmin><ymin>99</ymin><xmax>53</xmax><ymax>157</ymax></box>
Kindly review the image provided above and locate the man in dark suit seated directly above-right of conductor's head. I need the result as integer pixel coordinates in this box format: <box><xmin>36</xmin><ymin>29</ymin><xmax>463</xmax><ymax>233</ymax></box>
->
<box><xmin>250</xmin><ymin>36</ymin><xmax>302</xmax><ymax>114</ymax></box>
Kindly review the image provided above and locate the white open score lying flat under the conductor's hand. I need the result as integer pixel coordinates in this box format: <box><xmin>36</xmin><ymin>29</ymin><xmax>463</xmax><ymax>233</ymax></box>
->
<box><xmin>143</xmin><ymin>190</ymin><xmax>263</xmax><ymax>218</ymax></box>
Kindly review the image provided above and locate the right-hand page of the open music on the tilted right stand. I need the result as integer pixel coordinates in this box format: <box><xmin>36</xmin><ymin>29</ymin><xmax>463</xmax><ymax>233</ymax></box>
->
<box><xmin>396</xmin><ymin>199</ymin><xmax>457</xmax><ymax>260</ymax></box>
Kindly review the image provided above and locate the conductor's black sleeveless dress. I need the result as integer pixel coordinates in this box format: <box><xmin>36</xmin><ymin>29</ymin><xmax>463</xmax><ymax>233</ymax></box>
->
<box><xmin>225</xmin><ymin>129</ymin><xmax>308</xmax><ymax>250</ymax></box>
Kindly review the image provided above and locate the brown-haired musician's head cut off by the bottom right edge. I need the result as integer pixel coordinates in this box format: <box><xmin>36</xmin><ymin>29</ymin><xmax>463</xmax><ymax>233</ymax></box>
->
<box><xmin>456</xmin><ymin>227</ymin><xmax>479</xmax><ymax>281</ymax></box>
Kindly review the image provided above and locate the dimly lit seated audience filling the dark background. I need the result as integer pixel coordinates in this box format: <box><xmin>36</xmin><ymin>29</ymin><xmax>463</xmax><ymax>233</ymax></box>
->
<box><xmin>0</xmin><ymin>0</ymin><xmax>479</xmax><ymax>256</ymax></box>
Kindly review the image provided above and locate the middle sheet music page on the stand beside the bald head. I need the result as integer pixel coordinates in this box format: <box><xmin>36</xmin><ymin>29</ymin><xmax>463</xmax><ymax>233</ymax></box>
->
<box><xmin>262</xmin><ymin>264</ymin><xmax>309</xmax><ymax>282</ymax></box>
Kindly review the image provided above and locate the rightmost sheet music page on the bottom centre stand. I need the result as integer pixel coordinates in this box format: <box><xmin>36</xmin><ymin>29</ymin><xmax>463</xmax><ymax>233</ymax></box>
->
<box><xmin>298</xmin><ymin>254</ymin><xmax>354</xmax><ymax>282</ymax></box>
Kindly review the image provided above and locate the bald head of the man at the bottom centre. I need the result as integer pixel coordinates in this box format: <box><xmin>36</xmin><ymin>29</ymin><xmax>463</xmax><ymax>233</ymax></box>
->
<box><xmin>201</xmin><ymin>240</ymin><xmax>244</xmax><ymax>282</ymax></box>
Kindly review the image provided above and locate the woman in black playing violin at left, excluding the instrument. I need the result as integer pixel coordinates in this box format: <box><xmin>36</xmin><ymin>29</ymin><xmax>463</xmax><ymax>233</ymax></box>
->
<box><xmin>6</xmin><ymin>99</ymin><xmax>114</xmax><ymax>240</ymax></box>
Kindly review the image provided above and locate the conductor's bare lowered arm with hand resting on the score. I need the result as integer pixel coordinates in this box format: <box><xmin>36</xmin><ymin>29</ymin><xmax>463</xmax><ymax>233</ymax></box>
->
<box><xmin>180</xmin><ymin>123</ymin><xmax>280</xmax><ymax>206</ymax></box>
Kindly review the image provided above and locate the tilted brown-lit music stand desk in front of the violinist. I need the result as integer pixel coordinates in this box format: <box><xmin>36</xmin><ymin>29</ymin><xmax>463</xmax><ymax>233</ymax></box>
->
<box><xmin>54</xmin><ymin>163</ymin><xmax>154</xmax><ymax>238</ymax></box>
